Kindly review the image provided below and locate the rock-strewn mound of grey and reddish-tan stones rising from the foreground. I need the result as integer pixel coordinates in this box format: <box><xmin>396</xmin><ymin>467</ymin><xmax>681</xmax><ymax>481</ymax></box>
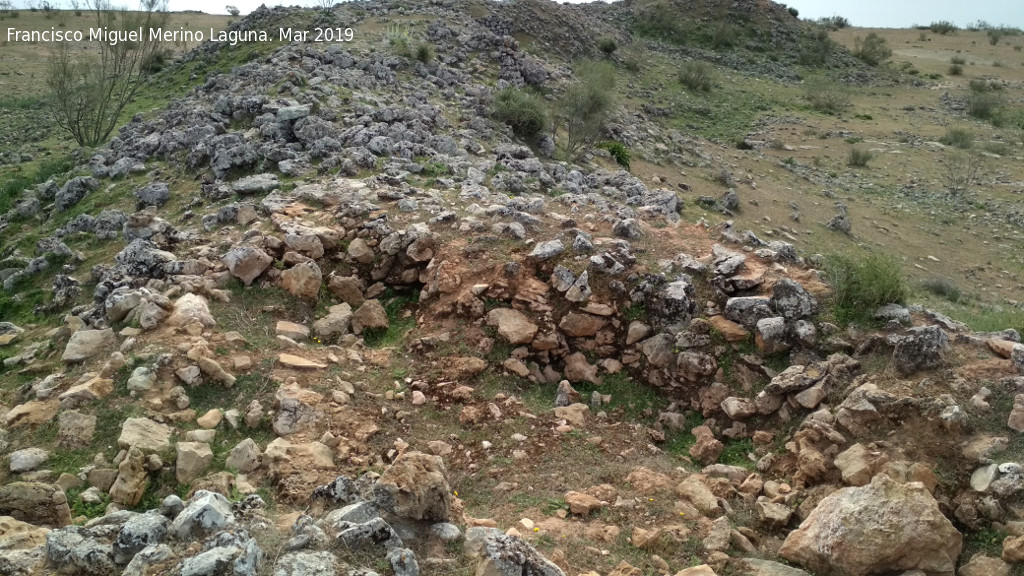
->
<box><xmin>0</xmin><ymin>0</ymin><xmax>1024</xmax><ymax>576</ymax></box>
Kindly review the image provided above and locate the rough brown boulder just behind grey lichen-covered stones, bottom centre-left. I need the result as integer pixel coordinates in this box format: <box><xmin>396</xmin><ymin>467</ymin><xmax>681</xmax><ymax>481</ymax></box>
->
<box><xmin>374</xmin><ymin>452</ymin><xmax>452</xmax><ymax>522</ymax></box>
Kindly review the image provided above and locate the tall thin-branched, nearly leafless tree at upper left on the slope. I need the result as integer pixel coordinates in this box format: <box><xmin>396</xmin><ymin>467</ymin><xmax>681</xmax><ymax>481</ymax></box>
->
<box><xmin>48</xmin><ymin>0</ymin><xmax>167</xmax><ymax>147</ymax></box>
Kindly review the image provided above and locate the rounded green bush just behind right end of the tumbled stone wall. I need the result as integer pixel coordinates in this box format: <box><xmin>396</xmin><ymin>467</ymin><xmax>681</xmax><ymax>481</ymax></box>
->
<box><xmin>823</xmin><ymin>252</ymin><xmax>907</xmax><ymax>323</ymax></box>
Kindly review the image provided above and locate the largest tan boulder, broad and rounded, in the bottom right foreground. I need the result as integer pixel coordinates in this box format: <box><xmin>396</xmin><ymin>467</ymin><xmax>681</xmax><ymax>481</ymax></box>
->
<box><xmin>779</xmin><ymin>475</ymin><xmax>964</xmax><ymax>576</ymax></box>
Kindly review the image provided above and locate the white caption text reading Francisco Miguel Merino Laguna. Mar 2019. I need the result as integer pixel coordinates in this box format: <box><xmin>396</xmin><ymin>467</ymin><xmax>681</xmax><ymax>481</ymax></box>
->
<box><xmin>7</xmin><ymin>27</ymin><xmax>354</xmax><ymax>46</ymax></box>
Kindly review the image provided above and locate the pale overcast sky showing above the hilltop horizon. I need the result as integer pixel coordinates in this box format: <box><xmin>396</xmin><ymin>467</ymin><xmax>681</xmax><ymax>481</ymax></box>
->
<box><xmin>28</xmin><ymin>0</ymin><xmax>1024</xmax><ymax>28</ymax></box>
